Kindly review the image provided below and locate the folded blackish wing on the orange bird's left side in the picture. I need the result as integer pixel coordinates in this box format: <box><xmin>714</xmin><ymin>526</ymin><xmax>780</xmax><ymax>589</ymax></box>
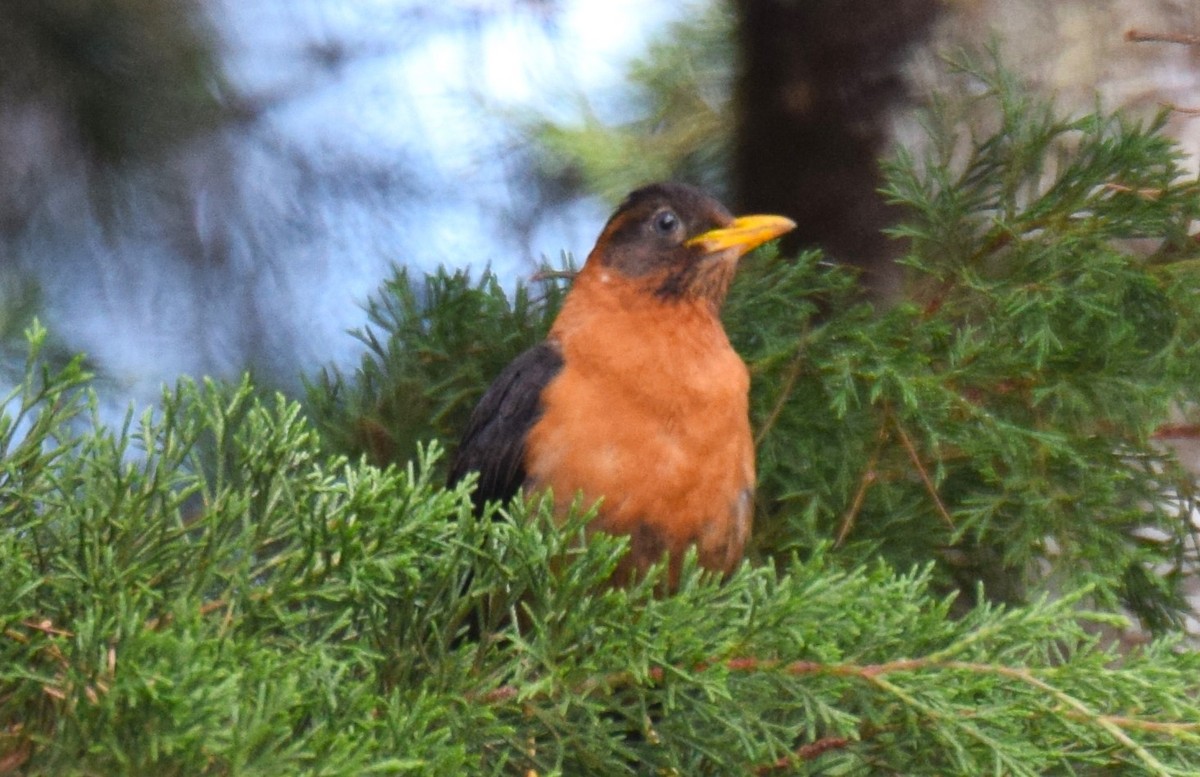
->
<box><xmin>449</xmin><ymin>342</ymin><xmax>563</xmax><ymax>512</ymax></box>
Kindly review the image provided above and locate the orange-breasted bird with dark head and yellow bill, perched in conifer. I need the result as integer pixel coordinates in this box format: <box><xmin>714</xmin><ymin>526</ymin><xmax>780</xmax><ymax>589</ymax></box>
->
<box><xmin>450</xmin><ymin>183</ymin><xmax>796</xmax><ymax>589</ymax></box>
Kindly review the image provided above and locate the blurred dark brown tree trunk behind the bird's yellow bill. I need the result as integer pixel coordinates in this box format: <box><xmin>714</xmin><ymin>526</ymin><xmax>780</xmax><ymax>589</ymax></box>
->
<box><xmin>733</xmin><ymin>0</ymin><xmax>941</xmax><ymax>295</ymax></box>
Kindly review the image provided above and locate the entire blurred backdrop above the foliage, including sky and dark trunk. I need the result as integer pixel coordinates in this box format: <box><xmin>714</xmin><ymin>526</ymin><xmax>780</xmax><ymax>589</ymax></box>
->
<box><xmin>0</xmin><ymin>0</ymin><xmax>1200</xmax><ymax>415</ymax></box>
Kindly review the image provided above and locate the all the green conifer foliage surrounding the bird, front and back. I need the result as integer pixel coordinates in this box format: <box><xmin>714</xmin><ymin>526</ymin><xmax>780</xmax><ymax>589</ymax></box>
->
<box><xmin>7</xmin><ymin>71</ymin><xmax>1200</xmax><ymax>776</ymax></box>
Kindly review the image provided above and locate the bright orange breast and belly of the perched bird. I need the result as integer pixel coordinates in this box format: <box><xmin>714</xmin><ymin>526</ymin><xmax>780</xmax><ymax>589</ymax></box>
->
<box><xmin>526</xmin><ymin>267</ymin><xmax>755</xmax><ymax>585</ymax></box>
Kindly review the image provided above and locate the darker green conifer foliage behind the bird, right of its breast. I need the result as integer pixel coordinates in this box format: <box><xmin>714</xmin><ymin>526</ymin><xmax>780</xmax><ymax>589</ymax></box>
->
<box><xmin>728</xmin><ymin>62</ymin><xmax>1200</xmax><ymax>627</ymax></box>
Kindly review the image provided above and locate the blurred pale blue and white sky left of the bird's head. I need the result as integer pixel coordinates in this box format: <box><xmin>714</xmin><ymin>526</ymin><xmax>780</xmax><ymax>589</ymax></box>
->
<box><xmin>4</xmin><ymin>0</ymin><xmax>686</xmax><ymax>420</ymax></box>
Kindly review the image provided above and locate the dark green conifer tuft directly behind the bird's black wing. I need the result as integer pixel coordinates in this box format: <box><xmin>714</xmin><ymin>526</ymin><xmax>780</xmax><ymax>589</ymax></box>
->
<box><xmin>308</xmin><ymin>270</ymin><xmax>563</xmax><ymax>463</ymax></box>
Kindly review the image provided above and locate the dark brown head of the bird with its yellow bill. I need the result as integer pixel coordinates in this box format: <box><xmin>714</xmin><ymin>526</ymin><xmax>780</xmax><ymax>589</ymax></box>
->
<box><xmin>587</xmin><ymin>183</ymin><xmax>796</xmax><ymax>307</ymax></box>
